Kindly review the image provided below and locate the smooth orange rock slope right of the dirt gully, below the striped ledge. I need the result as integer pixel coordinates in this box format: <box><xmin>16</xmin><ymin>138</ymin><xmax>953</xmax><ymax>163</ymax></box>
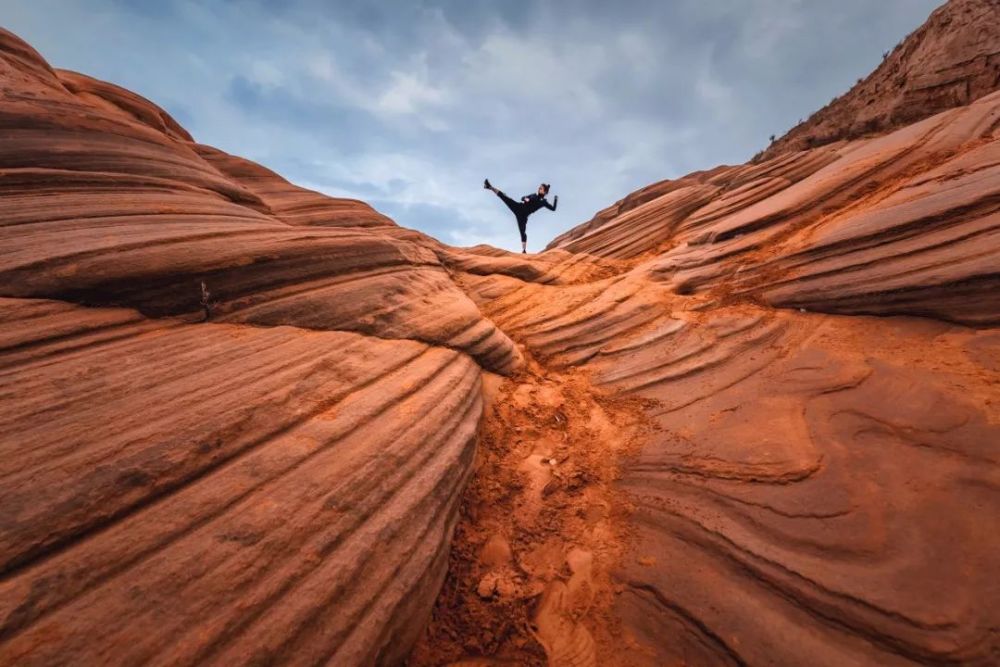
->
<box><xmin>474</xmin><ymin>264</ymin><xmax>1000</xmax><ymax>665</ymax></box>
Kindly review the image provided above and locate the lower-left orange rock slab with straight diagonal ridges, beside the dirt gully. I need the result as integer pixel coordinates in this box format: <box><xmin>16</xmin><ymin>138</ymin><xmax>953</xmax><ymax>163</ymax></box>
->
<box><xmin>0</xmin><ymin>299</ymin><xmax>481</xmax><ymax>665</ymax></box>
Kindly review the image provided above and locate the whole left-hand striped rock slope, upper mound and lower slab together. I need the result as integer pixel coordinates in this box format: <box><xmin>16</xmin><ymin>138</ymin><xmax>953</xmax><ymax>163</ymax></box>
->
<box><xmin>0</xmin><ymin>26</ymin><xmax>520</xmax><ymax>665</ymax></box>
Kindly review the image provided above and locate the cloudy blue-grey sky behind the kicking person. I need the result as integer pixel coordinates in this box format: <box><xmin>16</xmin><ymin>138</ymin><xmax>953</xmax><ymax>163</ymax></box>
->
<box><xmin>0</xmin><ymin>0</ymin><xmax>939</xmax><ymax>249</ymax></box>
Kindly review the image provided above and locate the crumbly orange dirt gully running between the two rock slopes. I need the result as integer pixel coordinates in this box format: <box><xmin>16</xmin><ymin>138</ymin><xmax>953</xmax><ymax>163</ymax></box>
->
<box><xmin>408</xmin><ymin>357</ymin><xmax>650</xmax><ymax>666</ymax></box>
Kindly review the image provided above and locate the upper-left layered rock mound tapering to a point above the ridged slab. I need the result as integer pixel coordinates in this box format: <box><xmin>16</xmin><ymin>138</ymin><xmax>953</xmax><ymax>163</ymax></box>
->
<box><xmin>0</xmin><ymin>26</ymin><xmax>518</xmax><ymax>372</ymax></box>
